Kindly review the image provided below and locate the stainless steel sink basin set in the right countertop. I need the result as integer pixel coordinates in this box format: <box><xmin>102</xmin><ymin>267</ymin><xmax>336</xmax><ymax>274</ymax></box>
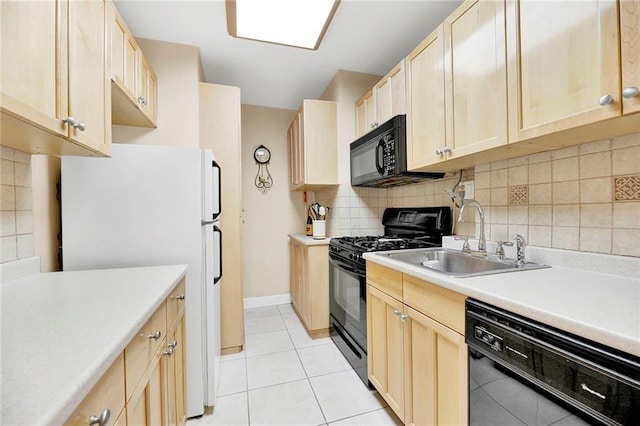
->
<box><xmin>387</xmin><ymin>248</ymin><xmax>550</xmax><ymax>278</ymax></box>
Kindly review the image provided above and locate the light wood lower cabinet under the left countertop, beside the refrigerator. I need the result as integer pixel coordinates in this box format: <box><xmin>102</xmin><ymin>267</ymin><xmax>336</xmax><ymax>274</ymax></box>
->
<box><xmin>65</xmin><ymin>280</ymin><xmax>187</xmax><ymax>426</ymax></box>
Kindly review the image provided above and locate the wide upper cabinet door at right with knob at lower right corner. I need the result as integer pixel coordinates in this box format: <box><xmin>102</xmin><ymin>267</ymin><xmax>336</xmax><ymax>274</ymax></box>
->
<box><xmin>507</xmin><ymin>0</ymin><xmax>621</xmax><ymax>142</ymax></box>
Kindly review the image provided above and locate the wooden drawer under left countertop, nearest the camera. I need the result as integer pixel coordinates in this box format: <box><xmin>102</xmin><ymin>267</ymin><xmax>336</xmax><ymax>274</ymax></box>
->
<box><xmin>65</xmin><ymin>354</ymin><xmax>125</xmax><ymax>425</ymax></box>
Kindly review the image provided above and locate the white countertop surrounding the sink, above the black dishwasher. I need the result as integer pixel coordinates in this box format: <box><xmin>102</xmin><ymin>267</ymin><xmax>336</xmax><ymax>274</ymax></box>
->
<box><xmin>364</xmin><ymin>250</ymin><xmax>640</xmax><ymax>356</ymax></box>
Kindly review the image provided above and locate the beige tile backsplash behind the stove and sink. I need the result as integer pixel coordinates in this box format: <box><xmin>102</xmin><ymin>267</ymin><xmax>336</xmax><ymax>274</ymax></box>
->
<box><xmin>316</xmin><ymin>133</ymin><xmax>640</xmax><ymax>257</ymax></box>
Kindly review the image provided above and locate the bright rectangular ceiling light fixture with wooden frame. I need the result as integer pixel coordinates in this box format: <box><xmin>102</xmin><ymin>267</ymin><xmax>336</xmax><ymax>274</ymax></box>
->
<box><xmin>226</xmin><ymin>0</ymin><xmax>340</xmax><ymax>50</ymax></box>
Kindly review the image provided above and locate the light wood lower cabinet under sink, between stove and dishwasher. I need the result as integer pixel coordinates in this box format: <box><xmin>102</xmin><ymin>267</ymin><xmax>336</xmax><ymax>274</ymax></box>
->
<box><xmin>367</xmin><ymin>263</ymin><xmax>468</xmax><ymax>425</ymax></box>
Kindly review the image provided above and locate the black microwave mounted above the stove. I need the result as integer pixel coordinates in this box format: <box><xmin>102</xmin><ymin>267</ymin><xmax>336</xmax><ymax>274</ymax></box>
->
<box><xmin>351</xmin><ymin>115</ymin><xmax>444</xmax><ymax>188</ymax></box>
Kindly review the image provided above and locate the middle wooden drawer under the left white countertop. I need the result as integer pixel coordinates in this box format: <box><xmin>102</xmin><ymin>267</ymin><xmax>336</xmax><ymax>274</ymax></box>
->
<box><xmin>124</xmin><ymin>303</ymin><xmax>167</xmax><ymax>400</ymax></box>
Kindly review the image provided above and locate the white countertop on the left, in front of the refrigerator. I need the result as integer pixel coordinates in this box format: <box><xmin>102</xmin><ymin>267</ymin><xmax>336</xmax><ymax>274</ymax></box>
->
<box><xmin>0</xmin><ymin>265</ymin><xmax>187</xmax><ymax>425</ymax></box>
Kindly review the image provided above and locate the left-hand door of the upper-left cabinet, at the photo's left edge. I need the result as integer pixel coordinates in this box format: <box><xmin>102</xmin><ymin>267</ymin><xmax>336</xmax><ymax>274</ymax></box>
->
<box><xmin>0</xmin><ymin>1</ymin><xmax>68</xmax><ymax>136</ymax></box>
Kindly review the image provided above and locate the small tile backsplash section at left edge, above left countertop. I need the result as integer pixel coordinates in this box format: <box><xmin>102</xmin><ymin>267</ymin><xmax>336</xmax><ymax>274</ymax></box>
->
<box><xmin>0</xmin><ymin>146</ymin><xmax>34</xmax><ymax>263</ymax></box>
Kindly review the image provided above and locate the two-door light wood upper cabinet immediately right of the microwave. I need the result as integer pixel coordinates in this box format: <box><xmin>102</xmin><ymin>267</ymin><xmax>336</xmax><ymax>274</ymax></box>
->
<box><xmin>406</xmin><ymin>0</ymin><xmax>507</xmax><ymax>170</ymax></box>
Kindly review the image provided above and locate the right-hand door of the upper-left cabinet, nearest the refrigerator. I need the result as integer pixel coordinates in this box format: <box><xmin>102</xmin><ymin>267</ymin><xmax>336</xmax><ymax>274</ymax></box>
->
<box><xmin>67</xmin><ymin>0</ymin><xmax>110</xmax><ymax>152</ymax></box>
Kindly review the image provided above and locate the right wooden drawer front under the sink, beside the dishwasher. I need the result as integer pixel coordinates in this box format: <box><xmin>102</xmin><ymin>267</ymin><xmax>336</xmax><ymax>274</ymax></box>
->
<box><xmin>402</xmin><ymin>275</ymin><xmax>466</xmax><ymax>334</ymax></box>
